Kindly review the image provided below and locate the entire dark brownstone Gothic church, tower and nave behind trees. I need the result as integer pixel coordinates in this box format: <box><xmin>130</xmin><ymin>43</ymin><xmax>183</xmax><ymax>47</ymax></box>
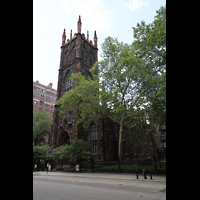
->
<box><xmin>49</xmin><ymin>16</ymin><xmax>157</xmax><ymax>161</ymax></box>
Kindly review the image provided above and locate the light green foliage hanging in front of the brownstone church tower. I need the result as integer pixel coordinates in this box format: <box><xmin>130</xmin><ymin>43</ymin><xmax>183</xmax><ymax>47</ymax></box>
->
<box><xmin>56</xmin><ymin>70</ymin><xmax>99</xmax><ymax>128</ymax></box>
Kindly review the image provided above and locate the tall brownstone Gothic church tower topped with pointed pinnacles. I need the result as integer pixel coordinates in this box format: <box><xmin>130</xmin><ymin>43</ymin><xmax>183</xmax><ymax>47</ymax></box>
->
<box><xmin>49</xmin><ymin>15</ymin><xmax>98</xmax><ymax>147</ymax></box>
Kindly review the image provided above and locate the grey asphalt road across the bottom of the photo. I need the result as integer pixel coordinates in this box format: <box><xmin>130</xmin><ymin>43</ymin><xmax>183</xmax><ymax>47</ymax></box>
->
<box><xmin>33</xmin><ymin>176</ymin><xmax>166</xmax><ymax>200</ymax></box>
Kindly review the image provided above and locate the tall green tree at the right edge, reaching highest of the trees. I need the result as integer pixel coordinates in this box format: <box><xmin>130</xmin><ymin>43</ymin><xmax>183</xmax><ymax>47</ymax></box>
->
<box><xmin>132</xmin><ymin>6</ymin><xmax>166</xmax><ymax>125</ymax></box>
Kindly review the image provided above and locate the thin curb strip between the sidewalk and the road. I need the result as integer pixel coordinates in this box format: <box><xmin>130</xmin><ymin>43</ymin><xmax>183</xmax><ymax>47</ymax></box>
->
<box><xmin>33</xmin><ymin>173</ymin><xmax>166</xmax><ymax>183</ymax></box>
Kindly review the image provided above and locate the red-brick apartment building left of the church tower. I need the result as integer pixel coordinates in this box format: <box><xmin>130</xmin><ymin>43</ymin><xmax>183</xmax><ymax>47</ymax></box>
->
<box><xmin>33</xmin><ymin>81</ymin><xmax>57</xmax><ymax>119</ymax></box>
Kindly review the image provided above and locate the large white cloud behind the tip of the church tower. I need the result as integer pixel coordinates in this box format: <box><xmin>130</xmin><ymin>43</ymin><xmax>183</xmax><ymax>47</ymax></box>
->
<box><xmin>61</xmin><ymin>0</ymin><xmax>111</xmax><ymax>30</ymax></box>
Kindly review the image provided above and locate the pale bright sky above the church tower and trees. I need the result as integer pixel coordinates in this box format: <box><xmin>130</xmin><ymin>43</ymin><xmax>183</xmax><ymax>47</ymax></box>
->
<box><xmin>33</xmin><ymin>0</ymin><xmax>166</xmax><ymax>89</ymax></box>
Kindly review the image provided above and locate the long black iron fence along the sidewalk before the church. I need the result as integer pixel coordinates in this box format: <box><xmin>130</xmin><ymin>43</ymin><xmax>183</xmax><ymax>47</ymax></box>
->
<box><xmin>40</xmin><ymin>158</ymin><xmax>166</xmax><ymax>175</ymax></box>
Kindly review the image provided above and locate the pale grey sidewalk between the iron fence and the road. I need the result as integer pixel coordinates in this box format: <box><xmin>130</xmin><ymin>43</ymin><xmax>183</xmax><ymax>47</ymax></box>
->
<box><xmin>33</xmin><ymin>171</ymin><xmax>166</xmax><ymax>183</ymax></box>
